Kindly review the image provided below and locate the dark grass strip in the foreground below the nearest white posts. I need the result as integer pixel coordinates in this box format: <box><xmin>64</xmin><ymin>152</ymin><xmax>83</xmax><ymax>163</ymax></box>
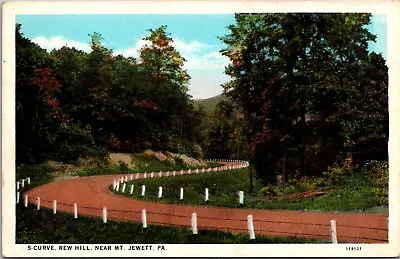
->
<box><xmin>16</xmin><ymin>204</ymin><xmax>319</xmax><ymax>244</ymax></box>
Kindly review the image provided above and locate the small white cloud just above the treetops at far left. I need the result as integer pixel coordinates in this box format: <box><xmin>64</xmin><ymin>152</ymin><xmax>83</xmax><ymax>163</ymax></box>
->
<box><xmin>32</xmin><ymin>36</ymin><xmax>90</xmax><ymax>52</ymax></box>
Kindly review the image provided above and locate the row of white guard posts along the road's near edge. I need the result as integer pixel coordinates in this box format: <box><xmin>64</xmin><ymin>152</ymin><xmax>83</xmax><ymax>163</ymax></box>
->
<box><xmin>17</xmin><ymin>195</ymin><xmax>338</xmax><ymax>244</ymax></box>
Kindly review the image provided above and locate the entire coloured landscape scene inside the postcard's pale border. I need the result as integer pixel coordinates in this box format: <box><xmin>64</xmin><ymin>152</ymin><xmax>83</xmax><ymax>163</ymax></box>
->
<box><xmin>5</xmin><ymin>9</ymin><xmax>390</xmax><ymax>255</ymax></box>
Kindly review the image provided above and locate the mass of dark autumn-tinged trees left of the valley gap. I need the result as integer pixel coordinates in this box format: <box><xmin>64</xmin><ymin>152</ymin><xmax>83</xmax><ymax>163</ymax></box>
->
<box><xmin>16</xmin><ymin>25</ymin><xmax>205</xmax><ymax>162</ymax></box>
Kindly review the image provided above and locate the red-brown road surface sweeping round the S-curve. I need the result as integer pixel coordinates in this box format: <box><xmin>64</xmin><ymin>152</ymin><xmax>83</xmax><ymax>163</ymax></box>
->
<box><xmin>23</xmin><ymin>162</ymin><xmax>388</xmax><ymax>243</ymax></box>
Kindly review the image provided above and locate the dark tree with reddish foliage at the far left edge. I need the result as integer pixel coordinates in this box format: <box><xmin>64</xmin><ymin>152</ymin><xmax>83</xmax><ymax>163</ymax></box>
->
<box><xmin>16</xmin><ymin>24</ymin><xmax>104</xmax><ymax>163</ymax></box>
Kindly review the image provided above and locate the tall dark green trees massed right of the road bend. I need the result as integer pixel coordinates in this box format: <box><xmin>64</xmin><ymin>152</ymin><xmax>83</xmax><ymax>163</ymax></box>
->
<box><xmin>222</xmin><ymin>13</ymin><xmax>388</xmax><ymax>185</ymax></box>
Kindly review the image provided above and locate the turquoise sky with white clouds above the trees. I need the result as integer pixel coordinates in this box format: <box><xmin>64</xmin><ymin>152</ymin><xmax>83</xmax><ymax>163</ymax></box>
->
<box><xmin>16</xmin><ymin>14</ymin><xmax>387</xmax><ymax>99</ymax></box>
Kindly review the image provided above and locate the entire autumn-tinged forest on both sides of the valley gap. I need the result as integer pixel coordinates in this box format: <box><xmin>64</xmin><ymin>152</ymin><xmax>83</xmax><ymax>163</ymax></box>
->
<box><xmin>15</xmin><ymin>13</ymin><xmax>389</xmax><ymax>186</ymax></box>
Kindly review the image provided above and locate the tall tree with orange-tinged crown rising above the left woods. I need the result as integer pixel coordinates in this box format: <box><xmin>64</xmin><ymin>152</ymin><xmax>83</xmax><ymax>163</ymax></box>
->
<box><xmin>140</xmin><ymin>25</ymin><xmax>198</xmax><ymax>151</ymax></box>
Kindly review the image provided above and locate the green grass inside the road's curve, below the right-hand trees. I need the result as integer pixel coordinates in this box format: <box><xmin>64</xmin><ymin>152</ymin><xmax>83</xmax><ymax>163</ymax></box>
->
<box><xmin>114</xmin><ymin>168</ymin><xmax>390</xmax><ymax>211</ymax></box>
